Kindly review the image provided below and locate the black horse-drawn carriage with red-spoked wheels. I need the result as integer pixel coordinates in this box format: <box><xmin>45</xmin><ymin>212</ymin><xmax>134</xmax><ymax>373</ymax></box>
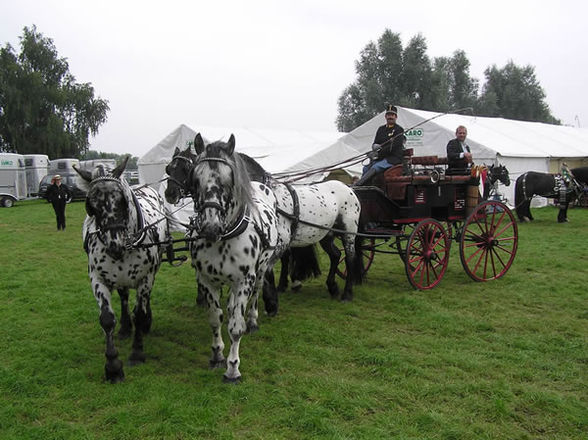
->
<box><xmin>339</xmin><ymin>149</ymin><xmax>518</xmax><ymax>290</ymax></box>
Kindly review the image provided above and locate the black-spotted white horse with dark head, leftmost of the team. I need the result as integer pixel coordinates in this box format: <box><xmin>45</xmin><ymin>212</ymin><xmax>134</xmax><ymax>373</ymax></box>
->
<box><xmin>76</xmin><ymin>156</ymin><xmax>168</xmax><ymax>383</ymax></box>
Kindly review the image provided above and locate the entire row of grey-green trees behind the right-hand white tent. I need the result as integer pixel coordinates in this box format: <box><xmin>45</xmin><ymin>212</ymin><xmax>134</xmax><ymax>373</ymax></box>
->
<box><xmin>336</xmin><ymin>29</ymin><xmax>561</xmax><ymax>132</ymax></box>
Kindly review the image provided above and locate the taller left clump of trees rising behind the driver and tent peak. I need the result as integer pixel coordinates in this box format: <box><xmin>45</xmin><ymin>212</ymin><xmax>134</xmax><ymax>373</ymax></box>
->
<box><xmin>336</xmin><ymin>29</ymin><xmax>478</xmax><ymax>131</ymax></box>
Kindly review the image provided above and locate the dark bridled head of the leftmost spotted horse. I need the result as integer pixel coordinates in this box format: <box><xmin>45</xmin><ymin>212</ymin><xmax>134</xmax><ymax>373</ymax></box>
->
<box><xmin>76</xmin><ymin>156</ymin><xmax>132</xmax><ymax>259</ymax></box>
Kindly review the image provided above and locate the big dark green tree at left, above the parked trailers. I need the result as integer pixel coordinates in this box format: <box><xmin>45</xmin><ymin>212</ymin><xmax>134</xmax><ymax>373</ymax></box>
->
<box><xmin>0</xmin><ymin>25</ymin><xmax>110</xmax><ymax>158</ymax></box>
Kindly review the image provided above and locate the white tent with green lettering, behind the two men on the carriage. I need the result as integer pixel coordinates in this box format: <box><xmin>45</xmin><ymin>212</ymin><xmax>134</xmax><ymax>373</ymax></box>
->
<box><xmin>290</xmin><ymin>107</ymin><xmax>588</xmax><ymax>204</ymax></box>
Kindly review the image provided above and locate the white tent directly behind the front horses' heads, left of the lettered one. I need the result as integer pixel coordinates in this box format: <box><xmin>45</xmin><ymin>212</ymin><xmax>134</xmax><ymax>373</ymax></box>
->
<box><xmin>138</xmin><ymin>124</ymin><xmax>344</xmax><ymax>229</ymax></box>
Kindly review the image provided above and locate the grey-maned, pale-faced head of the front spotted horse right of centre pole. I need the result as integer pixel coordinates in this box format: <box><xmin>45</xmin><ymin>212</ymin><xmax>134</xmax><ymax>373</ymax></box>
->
<box><xmin>190</xmin><ymin>133</ymin><xmax>251</xmax><ymax>241</ymax></box>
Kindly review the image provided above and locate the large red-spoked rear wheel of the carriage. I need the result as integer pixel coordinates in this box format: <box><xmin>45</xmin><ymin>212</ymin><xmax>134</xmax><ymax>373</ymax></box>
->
<box><xmin>459</xmin><ymin>200</ymin><xmax>518</xmax><ymax>281</ymax></box>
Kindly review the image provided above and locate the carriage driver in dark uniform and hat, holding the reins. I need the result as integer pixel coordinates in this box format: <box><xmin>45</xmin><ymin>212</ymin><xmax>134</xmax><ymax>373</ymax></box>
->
<box><xmin>356</xmin><ymin>105</ymin><xmax>406</xmax><ymax>185</ymax></box>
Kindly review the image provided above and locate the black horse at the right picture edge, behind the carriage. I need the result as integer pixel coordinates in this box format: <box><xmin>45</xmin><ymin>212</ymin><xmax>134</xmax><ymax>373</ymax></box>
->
<box><xmin>515</xmin><ymin>167</ymin><xmax>588</xmax><ymax>223</ymax></box>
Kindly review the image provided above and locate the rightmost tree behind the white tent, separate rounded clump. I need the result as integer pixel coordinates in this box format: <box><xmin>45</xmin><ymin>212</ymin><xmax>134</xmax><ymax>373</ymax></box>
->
<box><xmin>478</xmin><ymin>61</ymin><xmax>561</xmax><ymax>124</ymax></box>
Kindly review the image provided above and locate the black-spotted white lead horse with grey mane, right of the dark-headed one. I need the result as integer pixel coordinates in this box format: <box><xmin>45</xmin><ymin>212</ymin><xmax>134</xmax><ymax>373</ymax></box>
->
<box><xmin>187</xmin><ymin>133</ymin><xmax>289</xmax><ymax>383</ymax></box>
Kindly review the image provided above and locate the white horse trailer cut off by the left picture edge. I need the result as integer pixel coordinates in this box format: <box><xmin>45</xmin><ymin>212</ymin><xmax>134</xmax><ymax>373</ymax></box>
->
<box><xmin>0</xmin><ymin>153</ymin><xmax>27</xmax><ymax>208</ymax></box>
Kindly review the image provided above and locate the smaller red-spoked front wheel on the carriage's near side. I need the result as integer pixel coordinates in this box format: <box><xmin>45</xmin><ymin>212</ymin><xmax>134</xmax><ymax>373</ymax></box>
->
<box><xmin>405</xmin><ymin>219</ymin><xmax>449</xmax><ymax>290</ymax></box>
